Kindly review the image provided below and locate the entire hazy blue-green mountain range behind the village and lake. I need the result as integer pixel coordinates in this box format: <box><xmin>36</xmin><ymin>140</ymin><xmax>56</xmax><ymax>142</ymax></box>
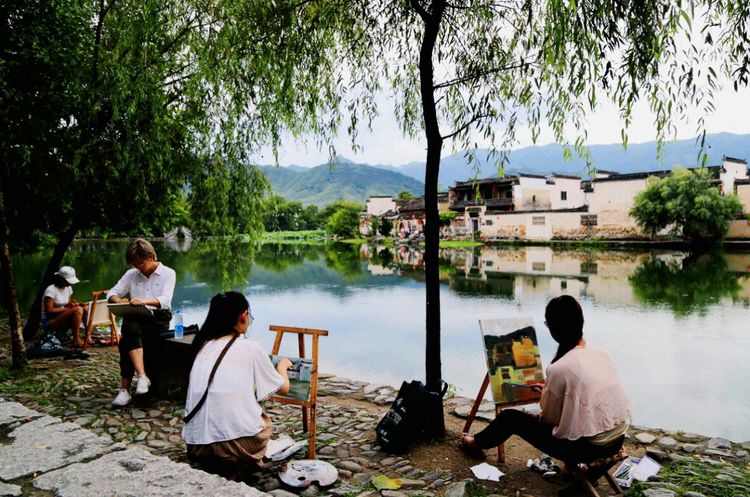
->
<box><xmin>261</xmin><ymin>133</ymin><xmax>750</xmax><ymax>206</ymax></box>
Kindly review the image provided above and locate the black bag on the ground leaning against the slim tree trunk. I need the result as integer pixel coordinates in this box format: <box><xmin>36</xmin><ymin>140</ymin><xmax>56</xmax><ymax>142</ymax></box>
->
<box><xmin>375</xmin><ymin>380</ymin><xmax>448</xmax><ymax>454</ymax></box>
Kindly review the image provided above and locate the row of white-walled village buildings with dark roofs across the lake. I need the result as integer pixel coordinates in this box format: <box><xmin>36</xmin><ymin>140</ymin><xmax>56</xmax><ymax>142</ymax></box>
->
<box><xmin>448</xmin><ymin>157</ymin><xmax>750</xmax><ymax>240</ymax></box>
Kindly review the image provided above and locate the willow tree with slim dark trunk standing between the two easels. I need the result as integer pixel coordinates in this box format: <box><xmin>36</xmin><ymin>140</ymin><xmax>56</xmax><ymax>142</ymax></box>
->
<box><xmin>284</xmin><ymin>0</ymin><xmax>747</xmax><ymax>432</ymax></box>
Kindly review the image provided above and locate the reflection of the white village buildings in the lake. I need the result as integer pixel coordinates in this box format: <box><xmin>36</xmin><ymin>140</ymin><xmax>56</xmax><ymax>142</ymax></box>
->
<box><xmin>356</xmin><ymin>240</ymin><xmax>750</xmax><ymax>305</ymax></box>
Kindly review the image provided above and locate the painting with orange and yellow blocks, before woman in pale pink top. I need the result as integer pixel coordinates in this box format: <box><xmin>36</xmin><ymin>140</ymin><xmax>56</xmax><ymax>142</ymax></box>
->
<box><xmin>479</xmin><ymin>318</ymin><xmax>544</xmax><ymax>404</ymax></box>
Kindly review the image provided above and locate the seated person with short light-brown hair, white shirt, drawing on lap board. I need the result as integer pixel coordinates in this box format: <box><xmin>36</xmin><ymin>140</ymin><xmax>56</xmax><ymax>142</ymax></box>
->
<box><xmin>107</xmin><ymin>238</ymin><xmax>175</xmax><ymax>407</ymax></box>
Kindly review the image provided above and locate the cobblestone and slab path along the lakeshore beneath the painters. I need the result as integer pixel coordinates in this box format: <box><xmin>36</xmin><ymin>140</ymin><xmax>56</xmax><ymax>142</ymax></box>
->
<box><xmin>0</xmin><ymin>349</ymin><xmax>750</xmax><ymax>497</ymax></box>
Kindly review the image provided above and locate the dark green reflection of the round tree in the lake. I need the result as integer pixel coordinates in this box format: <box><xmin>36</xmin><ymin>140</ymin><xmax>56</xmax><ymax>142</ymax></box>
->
<box><xmin>628</xmin><ymin>252</ymin><xmax>742</xmax><ymax>316</ymax></box>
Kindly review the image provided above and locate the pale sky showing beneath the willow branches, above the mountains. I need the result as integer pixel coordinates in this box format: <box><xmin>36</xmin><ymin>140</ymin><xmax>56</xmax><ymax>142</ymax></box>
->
<box><xmin>255</xmin><ymin>84</ymin><xmax>750</xmax><ymax>167</ymax></box>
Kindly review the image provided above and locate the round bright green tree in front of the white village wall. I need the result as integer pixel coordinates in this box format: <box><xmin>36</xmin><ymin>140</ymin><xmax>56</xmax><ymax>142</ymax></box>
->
<box><xmin>630</xmin><ymin>168</ymin><xmax>742</xmax><ymax>241</ymax></box>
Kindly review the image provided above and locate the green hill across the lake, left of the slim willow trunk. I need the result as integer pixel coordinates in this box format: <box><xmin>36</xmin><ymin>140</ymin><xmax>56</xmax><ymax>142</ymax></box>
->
<box><xmin>260</xmin><ymin>159</ymin><xmax>424</xmax><ymax>206</ymax></box>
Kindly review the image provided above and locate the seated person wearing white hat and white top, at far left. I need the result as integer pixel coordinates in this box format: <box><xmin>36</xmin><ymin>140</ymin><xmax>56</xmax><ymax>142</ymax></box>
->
<box><xmin>42</xmin><ymin>266</ymin><xmax>87</xmax><ymax>347</ymax></box>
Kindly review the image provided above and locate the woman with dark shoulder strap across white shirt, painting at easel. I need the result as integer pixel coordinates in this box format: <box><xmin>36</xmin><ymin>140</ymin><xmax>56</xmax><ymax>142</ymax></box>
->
<box><xmin>182</xmin><ymin>292</ymin><xmax>292</xmax><ymax>479</ymax></box>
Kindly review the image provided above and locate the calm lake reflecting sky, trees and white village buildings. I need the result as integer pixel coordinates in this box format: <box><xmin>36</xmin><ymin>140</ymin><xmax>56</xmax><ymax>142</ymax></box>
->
<box><xmin>14</xmin><ymin>241</ymin><xmax>750</xmax><ymax>441</ymax></box>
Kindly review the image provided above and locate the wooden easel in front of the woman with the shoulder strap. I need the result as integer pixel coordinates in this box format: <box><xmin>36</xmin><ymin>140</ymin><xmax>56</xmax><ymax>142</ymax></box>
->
<box><xmin>268</xmin><ymin>324</ymin><xmax>328</xmax><ymax>459</ymax></box>
